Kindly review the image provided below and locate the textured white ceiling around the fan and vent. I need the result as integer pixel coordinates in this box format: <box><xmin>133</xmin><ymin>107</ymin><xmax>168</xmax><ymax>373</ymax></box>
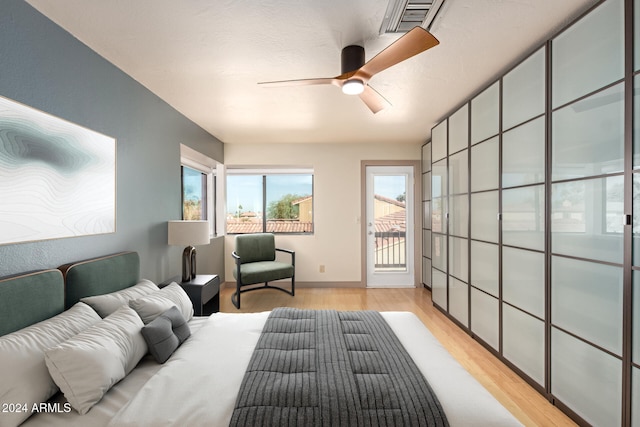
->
<box><xmin>27</xmin><ymin>0</ymin><xmax>598</xmax><ymax>143</ymax></box>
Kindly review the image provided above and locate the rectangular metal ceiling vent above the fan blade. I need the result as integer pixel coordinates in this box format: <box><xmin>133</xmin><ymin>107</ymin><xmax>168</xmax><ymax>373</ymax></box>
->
<box><xmin>380</xmin><ymin>0</ymin><xmax>444</xmax><ymax>34</ymax></box>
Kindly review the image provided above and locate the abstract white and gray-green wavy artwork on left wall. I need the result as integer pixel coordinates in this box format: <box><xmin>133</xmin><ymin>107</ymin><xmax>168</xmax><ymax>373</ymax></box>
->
<box><xmin>0</xmin><ymin>97</ymin><xmax>116</xmax><ymax>245</ymax></box>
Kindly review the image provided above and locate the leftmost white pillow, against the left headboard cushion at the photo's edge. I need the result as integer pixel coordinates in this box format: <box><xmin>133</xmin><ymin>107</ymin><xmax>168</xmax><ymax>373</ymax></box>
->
<box><xmin>0</xmin><ymin>302</ymin><xmax>101</xmax><ymax>426</ymax></box>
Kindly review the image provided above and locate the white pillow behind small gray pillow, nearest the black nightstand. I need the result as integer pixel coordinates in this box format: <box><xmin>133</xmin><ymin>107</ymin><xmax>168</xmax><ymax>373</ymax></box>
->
<box><xmin>129</xmin><ymin>282</ymin><xmax>193</xmax><ymax>325</ymax></box>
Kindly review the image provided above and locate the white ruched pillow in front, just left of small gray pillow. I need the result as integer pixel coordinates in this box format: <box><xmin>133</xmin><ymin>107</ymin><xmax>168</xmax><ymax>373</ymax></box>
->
<box><xmin>45</xmin><ymin>305</ymin><xmax>147</xmax><ymax>414</ymax></box>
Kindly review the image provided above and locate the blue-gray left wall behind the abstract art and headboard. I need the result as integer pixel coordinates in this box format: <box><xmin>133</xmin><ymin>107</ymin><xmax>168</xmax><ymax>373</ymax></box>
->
<box><xmin>0</xmin><ymin>0</ymin><xmax>224</xmax><ymax>282</ymax></box>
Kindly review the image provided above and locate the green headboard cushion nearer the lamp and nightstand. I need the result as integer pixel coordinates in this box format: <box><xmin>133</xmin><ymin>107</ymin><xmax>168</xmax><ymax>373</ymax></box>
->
<box><xmin>60</xmin><ymin>252</ymin><xmax>140</xmax><ymax>308</ymax></box>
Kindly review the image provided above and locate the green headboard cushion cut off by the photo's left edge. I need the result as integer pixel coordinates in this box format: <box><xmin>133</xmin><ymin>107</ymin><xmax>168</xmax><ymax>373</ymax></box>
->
<box><xmin>0</xmin><ymin>270</ymin><xmax>65</xmax><ymax>335</ymax></box>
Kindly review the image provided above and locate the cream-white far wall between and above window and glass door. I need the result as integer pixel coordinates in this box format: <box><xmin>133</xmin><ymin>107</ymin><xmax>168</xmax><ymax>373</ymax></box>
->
<box><xmin>224</xmin><ymin>143</ymin><xmax>422</xmax><ymax>285</ymax></box>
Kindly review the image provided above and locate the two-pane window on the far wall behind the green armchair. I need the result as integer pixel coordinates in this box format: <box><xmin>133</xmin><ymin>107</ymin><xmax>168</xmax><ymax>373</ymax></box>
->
<box><xmin>226</xmin><ymin>169</ymin><xmax>313</xmax><ymax>234</ymax></box>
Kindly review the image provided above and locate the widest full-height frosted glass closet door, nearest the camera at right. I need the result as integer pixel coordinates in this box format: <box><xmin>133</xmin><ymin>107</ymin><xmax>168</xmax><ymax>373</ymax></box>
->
<box><xmin>551</xmin><ymin>0</ymin><xmax>629</xmax><ymax>418</ymax></box>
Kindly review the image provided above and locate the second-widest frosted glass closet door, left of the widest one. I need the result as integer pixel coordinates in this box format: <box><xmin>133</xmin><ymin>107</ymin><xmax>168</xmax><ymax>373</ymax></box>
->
<box><xmin>502</xmin><ymin>44</ymin><xmax>546</xmax><ymax>386</ymax></box>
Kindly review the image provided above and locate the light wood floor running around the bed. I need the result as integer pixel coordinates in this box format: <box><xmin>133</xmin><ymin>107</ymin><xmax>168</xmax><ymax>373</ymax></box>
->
<box><xmin>220</xmin><ymin>287</ymin><xmax>576</xmax><ymax>426</ymax></box>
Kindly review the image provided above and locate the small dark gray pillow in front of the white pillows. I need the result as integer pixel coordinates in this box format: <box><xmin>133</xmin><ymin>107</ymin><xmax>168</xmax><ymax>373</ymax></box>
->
<box><xmin>142</xmin><ymin>306</ymin><xmax>191</xmax><ymax>363</ymax></box>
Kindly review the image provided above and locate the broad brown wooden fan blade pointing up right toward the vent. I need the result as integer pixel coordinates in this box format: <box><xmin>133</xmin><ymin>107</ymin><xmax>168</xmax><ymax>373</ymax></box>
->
<box><xmin>353</xmin><ymin>27</ymin><xmax>440</xmax><ymax>83</ymax></box>
